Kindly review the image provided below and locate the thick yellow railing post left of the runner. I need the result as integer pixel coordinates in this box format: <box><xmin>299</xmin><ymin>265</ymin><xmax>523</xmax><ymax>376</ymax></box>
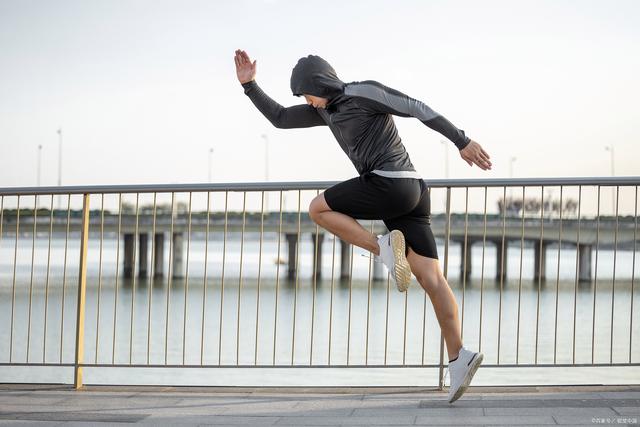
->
<box><xmin>73</xmin><ymin>194</ymin><xmax>89</xmax><ymax>389</ymax></box>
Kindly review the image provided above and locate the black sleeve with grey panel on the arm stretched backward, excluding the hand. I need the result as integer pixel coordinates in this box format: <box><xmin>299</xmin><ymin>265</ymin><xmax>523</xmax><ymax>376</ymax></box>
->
<box><xmin>345</xmin><ymin>80</ymin><xmax>470</xmax><ymax>150</ymax></box>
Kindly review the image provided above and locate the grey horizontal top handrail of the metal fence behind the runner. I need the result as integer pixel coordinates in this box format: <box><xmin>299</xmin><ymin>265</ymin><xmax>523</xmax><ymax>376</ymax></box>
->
<box><xmin>0</xmin><ymin>176</ymin><xmax>640</xmax><ymax>196</ymax></box>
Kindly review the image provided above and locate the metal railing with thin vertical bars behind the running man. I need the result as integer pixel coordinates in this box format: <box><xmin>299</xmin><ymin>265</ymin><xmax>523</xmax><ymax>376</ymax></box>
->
<box><xmin>0</xmin><ymin>177</ymin><xmax>640</xmax><ymax>387</ymax></box>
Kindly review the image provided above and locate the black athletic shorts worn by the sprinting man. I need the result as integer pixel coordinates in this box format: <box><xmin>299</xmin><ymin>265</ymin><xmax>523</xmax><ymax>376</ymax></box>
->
<box><xmin>324</xmin><ymin>172</ymin><xmax>438</xmax><ymax>259</ymax></box>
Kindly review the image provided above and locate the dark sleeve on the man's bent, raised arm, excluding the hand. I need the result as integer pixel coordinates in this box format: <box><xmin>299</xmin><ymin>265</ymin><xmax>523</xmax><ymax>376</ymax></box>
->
<box><xmin>242</xmin><ymin>80</ymin><xmax>326</xmax><ymax>129</ymax></box>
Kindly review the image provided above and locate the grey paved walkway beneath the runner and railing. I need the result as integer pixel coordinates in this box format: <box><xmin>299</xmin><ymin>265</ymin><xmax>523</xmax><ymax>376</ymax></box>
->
<box><xmin>0</xmin><ymin>384</ymin><xmax>640</xmax><ymax>426</ymax></box>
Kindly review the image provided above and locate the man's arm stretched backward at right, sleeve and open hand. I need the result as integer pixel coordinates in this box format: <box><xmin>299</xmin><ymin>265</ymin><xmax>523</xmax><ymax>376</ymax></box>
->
<box><xmin>345</xmin><ymin>80</ymin><xmax>491</xmax><ymax>170</ymax></box>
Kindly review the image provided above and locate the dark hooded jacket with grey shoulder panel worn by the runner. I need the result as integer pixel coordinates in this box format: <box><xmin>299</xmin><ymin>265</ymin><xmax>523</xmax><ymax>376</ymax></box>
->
<box><xmin>242</xmin><ymin>55</ymin><xmax>469</xmax><ymax>178</ymax></box>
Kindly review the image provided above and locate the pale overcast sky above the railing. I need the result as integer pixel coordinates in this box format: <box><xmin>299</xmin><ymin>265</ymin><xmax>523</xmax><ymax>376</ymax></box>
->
<box><xmin>0</xmin><ymin>0</ymin><xmax>640</xmax><ymax>194</ymax></box>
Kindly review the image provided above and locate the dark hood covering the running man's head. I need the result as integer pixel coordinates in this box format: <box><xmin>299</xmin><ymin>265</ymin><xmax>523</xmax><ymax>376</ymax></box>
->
<box><xmin>291</xmin><ymin>55</ymin><xmax>345</xmax><ymax>100</ymax></box>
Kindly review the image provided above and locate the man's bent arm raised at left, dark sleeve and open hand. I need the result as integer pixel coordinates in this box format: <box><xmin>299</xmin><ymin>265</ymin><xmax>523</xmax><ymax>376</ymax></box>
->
<box><xmin>234</xmin><ymin>50</ymin><xmax>326</xmax><ymax>129</ymax></box>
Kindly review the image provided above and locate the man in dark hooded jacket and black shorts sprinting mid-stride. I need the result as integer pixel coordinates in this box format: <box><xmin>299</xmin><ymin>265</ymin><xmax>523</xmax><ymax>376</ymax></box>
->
<box><xmin>234</xmin><ymin>50</ymin><xmax>491</xmax><ymax>402</ymax></box>
